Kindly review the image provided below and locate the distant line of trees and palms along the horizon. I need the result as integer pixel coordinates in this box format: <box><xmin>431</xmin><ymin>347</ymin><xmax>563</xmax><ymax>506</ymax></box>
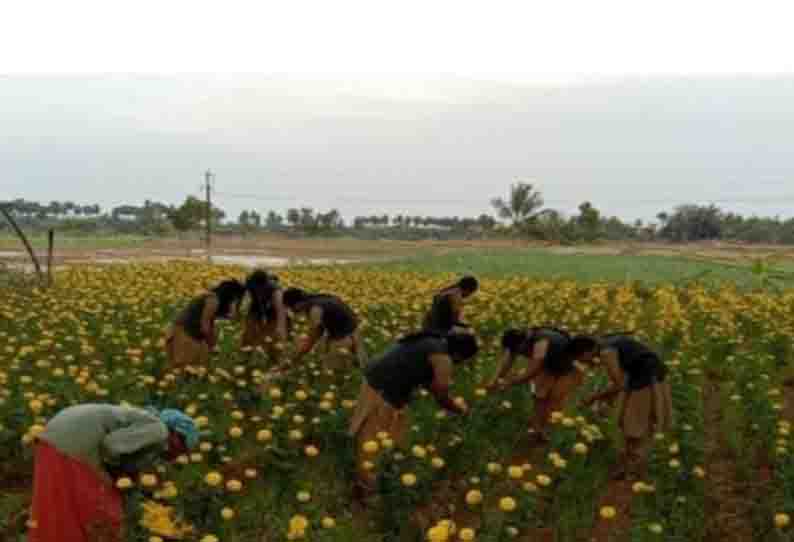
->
<box><xmin>0</xmin><ymin>186</ymin><xmax>794</xmax><ymax>244</ymax></box>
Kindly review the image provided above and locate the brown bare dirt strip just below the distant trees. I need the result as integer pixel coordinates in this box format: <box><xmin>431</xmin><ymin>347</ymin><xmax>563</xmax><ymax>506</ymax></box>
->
<box><xmin>0</xmin><ymin>235</ymin><xmax>794</xmax><ymax>267</ymax></box>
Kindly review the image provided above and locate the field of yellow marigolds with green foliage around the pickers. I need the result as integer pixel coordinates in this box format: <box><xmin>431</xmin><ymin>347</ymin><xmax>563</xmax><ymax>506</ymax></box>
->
<box><xmin>0</xmin><ymin>263</ymin><xmax>794</xmax><ymax>542</ymax></box>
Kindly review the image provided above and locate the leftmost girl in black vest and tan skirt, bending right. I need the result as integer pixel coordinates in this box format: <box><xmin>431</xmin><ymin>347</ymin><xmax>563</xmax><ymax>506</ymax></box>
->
<box><xmin>165</xmin><ymin>280</ymin><xmax>245</xmax><ymax>369</ymax></box>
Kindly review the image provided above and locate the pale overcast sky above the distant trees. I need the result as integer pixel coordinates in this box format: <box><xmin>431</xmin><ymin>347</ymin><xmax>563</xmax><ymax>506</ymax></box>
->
<box><xmin>0</xmin><ymin>0</ymin><xmax>794</xmax><ymax>220</ymax></box>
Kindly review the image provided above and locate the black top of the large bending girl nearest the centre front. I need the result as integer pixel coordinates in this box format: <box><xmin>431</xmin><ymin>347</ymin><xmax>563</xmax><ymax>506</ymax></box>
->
<box><xmin>364</xmin><ymin>337</ymin><xmax>448</xmax><ymax>408</ymax></box>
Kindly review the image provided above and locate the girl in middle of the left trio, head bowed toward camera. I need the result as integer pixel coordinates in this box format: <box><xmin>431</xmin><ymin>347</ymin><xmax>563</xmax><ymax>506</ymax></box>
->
<box><xmin>240</xmin><ymin>270</ymin><xmax>288</xmax><ymax>363</ymax></box>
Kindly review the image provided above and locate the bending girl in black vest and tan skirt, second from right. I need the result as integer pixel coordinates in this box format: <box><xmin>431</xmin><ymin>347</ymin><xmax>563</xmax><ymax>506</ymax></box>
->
<box><xmin>488</xmin><ymin>327</ymin><xmax>598</xmax><ymax>441</ymax></box>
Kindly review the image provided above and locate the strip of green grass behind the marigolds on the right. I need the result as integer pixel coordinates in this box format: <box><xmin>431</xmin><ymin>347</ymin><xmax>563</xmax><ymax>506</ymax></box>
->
<box><xmin>370</xmin><ymin>248</ymin><xmax>794</xmax><ymax>287</ymax></box>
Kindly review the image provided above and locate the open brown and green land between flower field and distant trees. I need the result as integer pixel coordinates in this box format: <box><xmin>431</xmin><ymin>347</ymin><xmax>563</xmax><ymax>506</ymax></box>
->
<box><xmin>0</xmin><ymin>236</ymin><xmax>794</xmax><ymax>286</ymax></box>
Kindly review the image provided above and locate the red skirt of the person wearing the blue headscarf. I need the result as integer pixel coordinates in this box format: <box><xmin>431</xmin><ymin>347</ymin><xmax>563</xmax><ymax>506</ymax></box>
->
<box><xmin>28</xmin><ymin>441</ymin><xmax>124</xmax><ymax>542</ymax></box>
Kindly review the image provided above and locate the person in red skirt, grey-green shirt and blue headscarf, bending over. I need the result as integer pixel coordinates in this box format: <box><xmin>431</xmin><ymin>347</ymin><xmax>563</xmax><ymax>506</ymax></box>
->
<box><xmin>28</xmin><ymin>404</ymin><xmax>199</xmax><ymax>542</ymax></box>
